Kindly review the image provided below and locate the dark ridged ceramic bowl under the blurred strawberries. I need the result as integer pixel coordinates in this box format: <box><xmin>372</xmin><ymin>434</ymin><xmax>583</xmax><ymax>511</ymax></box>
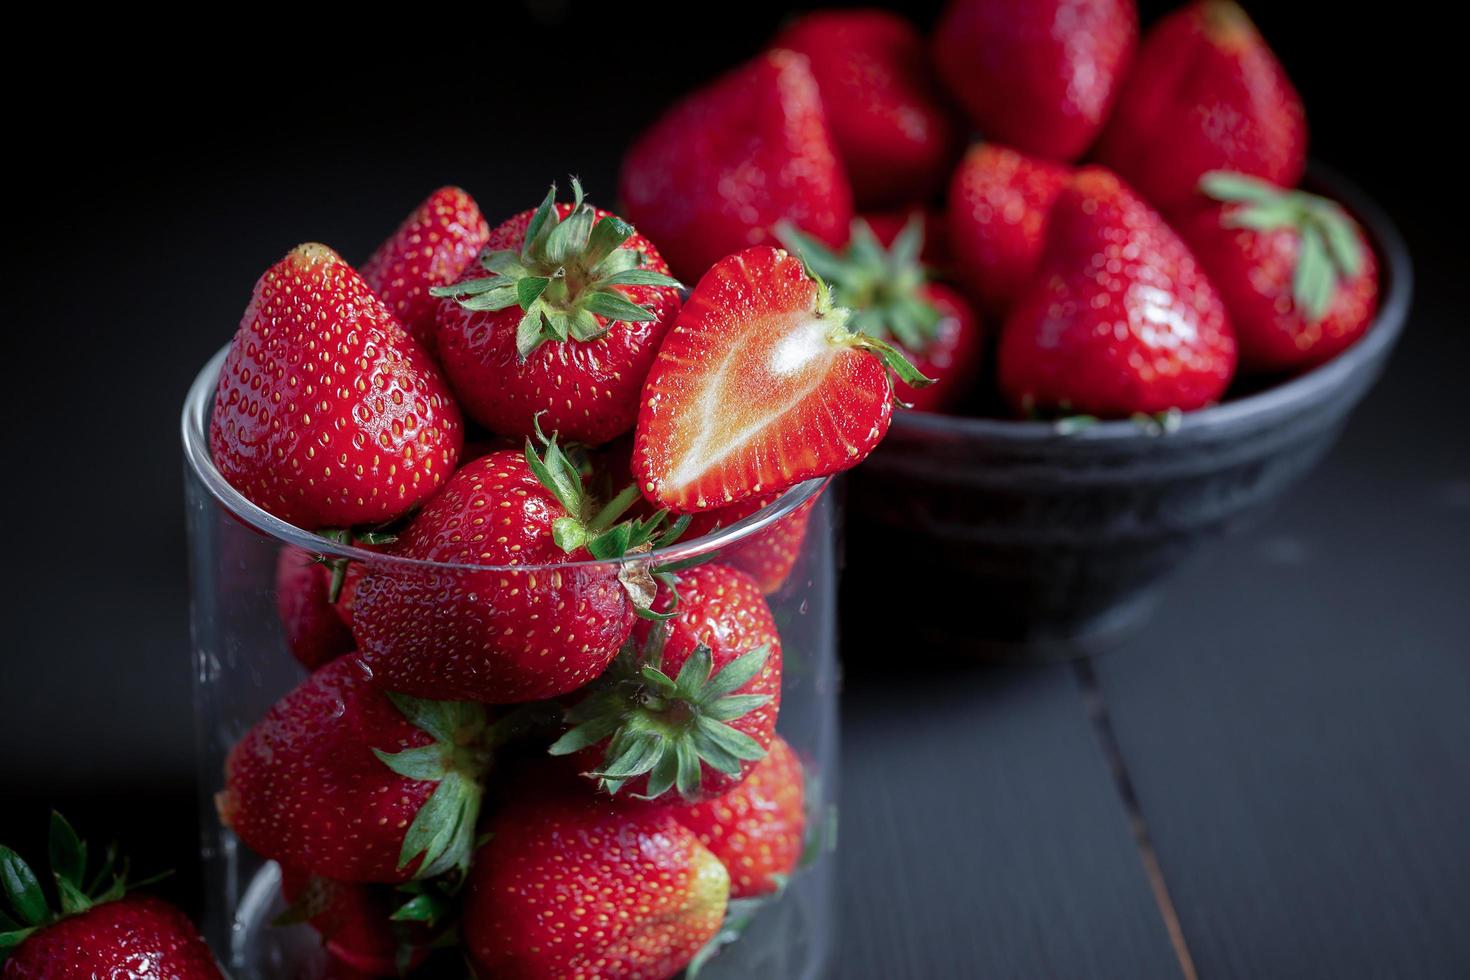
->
<box><xmin>845</xmin><ymin>170</ymin><xmax>1413</xmax><ymax>657</ymax></box>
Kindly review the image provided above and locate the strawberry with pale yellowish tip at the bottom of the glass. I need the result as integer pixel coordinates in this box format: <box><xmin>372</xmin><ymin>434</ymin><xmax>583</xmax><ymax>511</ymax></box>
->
<box><xmin>463</xmin><ymin>790</ymin><xmax>729</xmax><ymax>980</ymax></box>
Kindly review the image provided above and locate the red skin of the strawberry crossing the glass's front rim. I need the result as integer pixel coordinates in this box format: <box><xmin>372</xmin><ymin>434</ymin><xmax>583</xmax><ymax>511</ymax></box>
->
<box><xmin>353</xmin><ymin>451</ymin><xmax>634</xmax><ymax>704</ymax></box>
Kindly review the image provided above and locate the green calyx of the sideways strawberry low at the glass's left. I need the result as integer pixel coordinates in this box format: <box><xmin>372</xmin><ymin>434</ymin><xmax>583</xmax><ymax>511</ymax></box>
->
<box><xmin>373</xmin><ymin>693</ymin><xmax>545</xmax><ymax>880</ymax></box>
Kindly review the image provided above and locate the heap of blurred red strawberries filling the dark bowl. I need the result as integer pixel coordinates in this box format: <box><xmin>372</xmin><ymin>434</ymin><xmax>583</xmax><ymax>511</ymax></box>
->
<box><xmin>620</xmin><ymin>0</ymin><xmax>1379</xmax><ymax>428</ymax></box>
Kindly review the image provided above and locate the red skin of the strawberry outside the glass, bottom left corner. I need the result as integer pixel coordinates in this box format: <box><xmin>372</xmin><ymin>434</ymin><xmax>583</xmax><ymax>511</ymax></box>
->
<box><xmin>0</xmin><ymin>895</ymin><xmax>222</xmax><ymax>980</ymax></box>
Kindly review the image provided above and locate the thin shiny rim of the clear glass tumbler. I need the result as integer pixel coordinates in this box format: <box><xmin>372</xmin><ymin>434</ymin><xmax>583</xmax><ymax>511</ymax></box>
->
<box><xmin>181</xmin><ymin>344</ymin><xmax>832</xmax><ymax>572</ymax></box>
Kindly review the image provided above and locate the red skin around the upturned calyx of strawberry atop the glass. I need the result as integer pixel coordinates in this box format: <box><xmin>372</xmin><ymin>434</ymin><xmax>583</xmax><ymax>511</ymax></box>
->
<box><xmin>437</xmin><ymin>204</ymin><xmax>679</xmax><ymax>445</ymax></box>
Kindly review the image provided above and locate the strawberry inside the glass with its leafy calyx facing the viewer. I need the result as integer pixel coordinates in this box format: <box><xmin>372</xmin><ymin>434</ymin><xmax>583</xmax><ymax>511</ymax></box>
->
<box><xmin>551</xmin><ymin>564</ymin><xmax>781</xmax><ymax>801</ymax></box>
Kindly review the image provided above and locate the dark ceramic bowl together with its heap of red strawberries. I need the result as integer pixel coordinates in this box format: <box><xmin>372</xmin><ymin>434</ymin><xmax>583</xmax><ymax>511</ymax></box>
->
<box><xmin>599</xmin><ymin>0</ymin><xmax>1408</xmax><ymax>652</ymax></box>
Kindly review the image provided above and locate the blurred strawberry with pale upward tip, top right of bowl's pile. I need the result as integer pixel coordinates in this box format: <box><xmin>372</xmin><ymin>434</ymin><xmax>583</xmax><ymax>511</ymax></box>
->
<box><xmin>1098</xmin><ymin>0</ymin><xmax>1307</xmax><ymax>212</ymax></box>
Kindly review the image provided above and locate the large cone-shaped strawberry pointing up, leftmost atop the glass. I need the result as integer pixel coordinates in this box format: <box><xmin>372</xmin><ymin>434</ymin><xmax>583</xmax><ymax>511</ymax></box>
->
<box><xmin>209</xmin><ymin>244</ymin><xmax>463</xmax><ymax>530</ymax></box>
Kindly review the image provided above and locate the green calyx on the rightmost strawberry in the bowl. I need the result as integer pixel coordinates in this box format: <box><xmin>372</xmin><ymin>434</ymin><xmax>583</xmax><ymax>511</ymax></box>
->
<box><xmin>1200</xmin><ymin>170</ymin><xmax>1364</xmax><ymax>323</ymax></box>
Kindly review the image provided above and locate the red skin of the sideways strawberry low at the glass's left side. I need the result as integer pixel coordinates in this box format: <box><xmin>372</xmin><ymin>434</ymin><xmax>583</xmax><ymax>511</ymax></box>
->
<box><xmin>218</xmin><ymin>657</ymin><xmax>437</xmax><ymax>883</ymax></box>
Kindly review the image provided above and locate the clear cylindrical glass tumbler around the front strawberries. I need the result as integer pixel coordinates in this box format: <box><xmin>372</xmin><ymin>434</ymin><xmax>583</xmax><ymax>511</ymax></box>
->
<box><xmin>182</xmin><ymin>351</ymin><xmax>838</xmax><ymax>980</ymax></box>
